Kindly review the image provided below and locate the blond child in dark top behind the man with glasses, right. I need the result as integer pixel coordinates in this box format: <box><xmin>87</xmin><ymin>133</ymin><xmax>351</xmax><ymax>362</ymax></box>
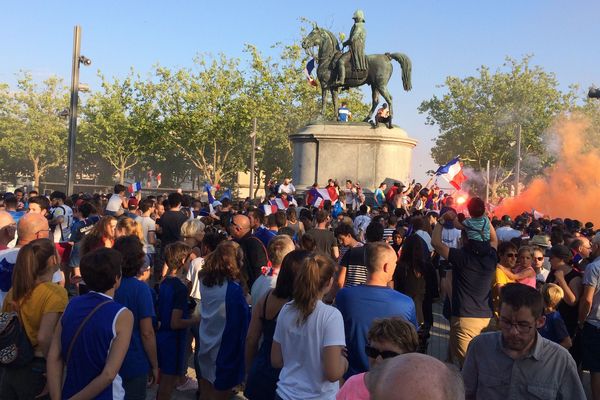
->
<box><xmin>538</xmin><ymin>283</ymin><xmax>573</xmax><ymax>349</ymax></box>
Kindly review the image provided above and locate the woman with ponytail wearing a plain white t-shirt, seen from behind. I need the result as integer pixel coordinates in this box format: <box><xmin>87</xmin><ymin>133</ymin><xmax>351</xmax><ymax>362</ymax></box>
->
<box><xmin>271</xmin><ymin>253</ymin><xmax>348</xmax><ymax>400</ymax></box>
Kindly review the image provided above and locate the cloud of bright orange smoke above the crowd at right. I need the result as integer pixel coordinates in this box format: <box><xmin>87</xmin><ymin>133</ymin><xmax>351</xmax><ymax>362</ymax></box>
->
<box><xmin>495</xmin><ymin>118</ymin><xmax>600</xmax><ymax>226</ymax></box>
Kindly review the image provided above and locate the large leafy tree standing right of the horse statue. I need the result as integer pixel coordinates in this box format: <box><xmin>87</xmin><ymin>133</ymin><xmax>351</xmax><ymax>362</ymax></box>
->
<box><xmin>419</xmin><ymin>56</ymin><xmax>574</xmax><ymax>199</ymax></box>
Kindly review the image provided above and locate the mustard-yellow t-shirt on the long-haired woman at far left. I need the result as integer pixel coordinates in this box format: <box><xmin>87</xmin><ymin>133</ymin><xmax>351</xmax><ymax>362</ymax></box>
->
<box><xmin>2</xmin><ymin>282</ymin><xmax>69</xmax><ymax>350</ymax></box>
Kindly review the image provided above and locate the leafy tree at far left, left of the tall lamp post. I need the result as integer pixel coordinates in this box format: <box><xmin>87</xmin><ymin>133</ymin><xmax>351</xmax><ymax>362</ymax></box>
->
<box><xmin>0</xmin><ymin>73</ymin><xmax>68</xmax><ymax>188</ymax></box>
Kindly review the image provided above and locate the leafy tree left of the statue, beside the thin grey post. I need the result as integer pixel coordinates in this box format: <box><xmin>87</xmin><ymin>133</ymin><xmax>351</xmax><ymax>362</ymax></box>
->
<box><xmin>155</xmin><ymin>55</ymin><xmax>252</xmax><ymax>184</ymax></box>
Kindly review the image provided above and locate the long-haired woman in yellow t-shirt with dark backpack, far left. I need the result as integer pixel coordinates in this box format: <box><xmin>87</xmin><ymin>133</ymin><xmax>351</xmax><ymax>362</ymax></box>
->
<box><xmin>0</xmin><ymin>239</ymin><xmax>68</xmax><ymax>399</ymax></box>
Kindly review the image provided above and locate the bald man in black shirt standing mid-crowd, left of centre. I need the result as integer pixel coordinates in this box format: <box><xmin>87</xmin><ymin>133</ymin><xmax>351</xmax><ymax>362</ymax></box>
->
<box><xmin>229</xmin><ymin>214</ymin><xmax>268</xmax><ymax>289</ymax></box>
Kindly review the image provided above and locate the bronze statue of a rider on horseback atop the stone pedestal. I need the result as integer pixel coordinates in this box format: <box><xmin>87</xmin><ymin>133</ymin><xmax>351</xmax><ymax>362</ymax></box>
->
<box><xmin>302</xmin><ymin>10</ymin><xmax>412</xmax><ymax>128</ymax></box>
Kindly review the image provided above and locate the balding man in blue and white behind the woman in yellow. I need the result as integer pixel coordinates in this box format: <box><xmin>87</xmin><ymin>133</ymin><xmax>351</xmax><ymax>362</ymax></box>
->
<box><xmin>0</xmin><ymin>213</ymin><xmax>50</xmax><ymax>306</ymax></box>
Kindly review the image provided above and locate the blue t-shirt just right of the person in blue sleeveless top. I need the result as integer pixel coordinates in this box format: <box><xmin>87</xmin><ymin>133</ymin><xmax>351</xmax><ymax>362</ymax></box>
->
<box><xmin>115</xmin><ymin>278</ymin><xmax>155</xmax><ymax>379</ymax></box>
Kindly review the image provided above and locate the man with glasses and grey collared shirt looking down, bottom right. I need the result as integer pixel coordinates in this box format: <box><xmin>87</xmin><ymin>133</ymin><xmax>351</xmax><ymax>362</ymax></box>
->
<box><xmin>462</xmin><ymin>283</ymin><xmax>586</xmax><ymax>400</ymax></box>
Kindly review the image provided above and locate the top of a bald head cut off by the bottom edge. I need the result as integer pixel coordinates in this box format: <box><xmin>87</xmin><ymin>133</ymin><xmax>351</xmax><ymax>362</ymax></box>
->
<box><xmin>367</xmin><ymin>353</ymin><xmax>465</xmax><ymax>400</ymax></box>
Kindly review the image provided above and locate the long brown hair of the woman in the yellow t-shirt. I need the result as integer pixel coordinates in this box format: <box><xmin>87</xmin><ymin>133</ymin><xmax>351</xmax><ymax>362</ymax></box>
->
<box><xmin>12</xmin><ymin>239</ymin><xmax>58</xmax><ymax>302</ymax></box>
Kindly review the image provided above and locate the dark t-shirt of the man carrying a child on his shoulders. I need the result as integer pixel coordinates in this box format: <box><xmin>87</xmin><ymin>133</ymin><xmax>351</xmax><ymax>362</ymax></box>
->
<box><xmin>448</xmin><ymin>247</ymin><xmax>497</xmax><ymax>318</ymax></box>
